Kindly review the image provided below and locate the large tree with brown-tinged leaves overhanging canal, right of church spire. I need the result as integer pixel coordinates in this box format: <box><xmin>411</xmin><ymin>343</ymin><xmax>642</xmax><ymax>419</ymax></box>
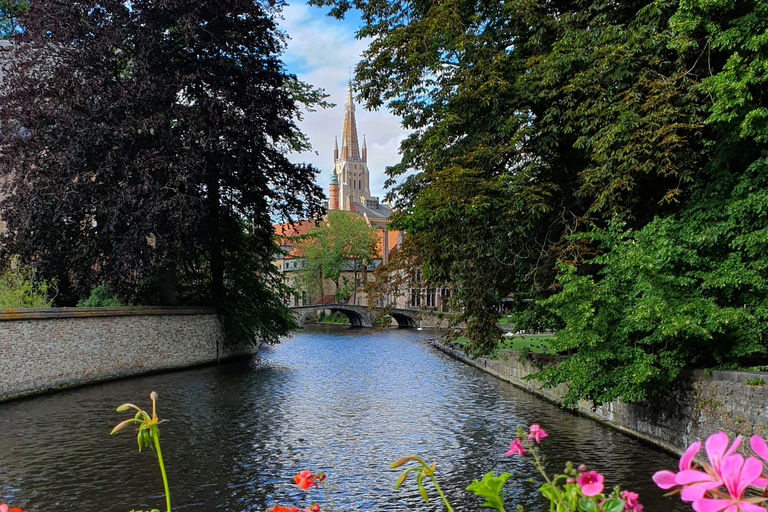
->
<box><xmin>314</xmin><ymin>0</ymin><xmax>701</xmax><ymax>354</ymax></box>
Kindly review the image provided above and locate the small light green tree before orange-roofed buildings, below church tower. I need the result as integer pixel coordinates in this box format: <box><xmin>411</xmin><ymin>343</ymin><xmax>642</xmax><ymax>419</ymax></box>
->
<box><xmin>296</xmin><ymin>210</ymin><xmax>378</xmax><ymax>301</ymax></box>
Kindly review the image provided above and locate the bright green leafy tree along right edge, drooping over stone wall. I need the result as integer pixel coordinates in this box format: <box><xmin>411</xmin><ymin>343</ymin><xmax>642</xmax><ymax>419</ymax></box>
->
<box><xmin>537</xmin><ymin>2</ymin><xmax>768</xmax><ymax>402</ymax></box>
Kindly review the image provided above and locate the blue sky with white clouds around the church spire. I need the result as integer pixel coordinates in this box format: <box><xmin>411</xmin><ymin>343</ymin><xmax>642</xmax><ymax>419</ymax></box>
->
<box><xmin>280</xmin><ymin>1</ymin><xmax>407</xmax><ymax>199</ymax></box>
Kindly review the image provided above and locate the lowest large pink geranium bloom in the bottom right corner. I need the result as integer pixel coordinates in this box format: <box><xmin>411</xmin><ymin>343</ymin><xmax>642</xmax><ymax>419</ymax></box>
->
<box><xmin>693</xmin><ymin>454</ymin><xmax>766</xmax><ymax>512</ymax></box>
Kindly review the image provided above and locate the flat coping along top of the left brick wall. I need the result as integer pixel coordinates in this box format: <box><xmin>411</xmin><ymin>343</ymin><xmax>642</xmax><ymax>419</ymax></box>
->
<box><xmin>0</xmin><ymin>306</ymin><xmax>217</xmax><ymax>322</ymax></box>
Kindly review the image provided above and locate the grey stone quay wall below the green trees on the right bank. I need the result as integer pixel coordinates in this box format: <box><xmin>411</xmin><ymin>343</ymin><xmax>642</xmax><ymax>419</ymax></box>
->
<box><xmin>432</xmin><ymin>341</ymin><xmax>768</xmax><ymax>455</ymax></box>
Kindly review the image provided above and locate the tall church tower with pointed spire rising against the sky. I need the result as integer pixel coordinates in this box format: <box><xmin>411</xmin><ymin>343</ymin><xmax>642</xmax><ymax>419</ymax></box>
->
<box><xmin>331</xmin><ymin>81</ymin><xmax>371</xmax><ymax>211</ymax></box>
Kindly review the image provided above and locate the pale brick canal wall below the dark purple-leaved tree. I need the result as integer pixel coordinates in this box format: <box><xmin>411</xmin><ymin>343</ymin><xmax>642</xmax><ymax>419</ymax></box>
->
<box><xmin>0</xmin><ymin>307</ymin><xmax>253</xmax><ymax>400</ymax></box>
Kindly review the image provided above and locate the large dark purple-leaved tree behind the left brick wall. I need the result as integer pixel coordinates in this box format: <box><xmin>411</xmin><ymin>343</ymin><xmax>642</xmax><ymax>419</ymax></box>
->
<box><xmin>0</xmin><ymin>0</ymin><xmax>324</xmax><ymax>341</ymax></box>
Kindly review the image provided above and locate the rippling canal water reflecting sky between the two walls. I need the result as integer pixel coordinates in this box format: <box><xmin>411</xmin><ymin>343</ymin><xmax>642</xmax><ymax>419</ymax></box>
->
<box><xmin>0</xmin><ymin>327</ymin><xmax>690</xmax><ymax>512</ymax></box>
